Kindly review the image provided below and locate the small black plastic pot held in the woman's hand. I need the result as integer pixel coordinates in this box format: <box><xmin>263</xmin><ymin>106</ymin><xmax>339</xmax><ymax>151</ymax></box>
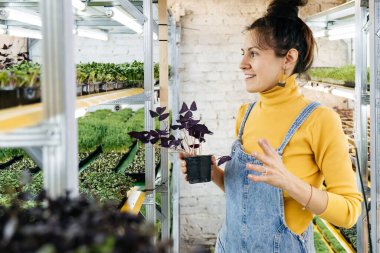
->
<box><xmin>185</xmin><ymin>155</ymin><xmax>211</xmax><ymax>184</ymax></box>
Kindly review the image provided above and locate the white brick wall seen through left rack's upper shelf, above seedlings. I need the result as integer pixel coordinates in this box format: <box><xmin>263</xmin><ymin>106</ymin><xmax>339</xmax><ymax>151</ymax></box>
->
<box><xmin>31</xmin><ymin>34</ymin><xmax>158</xmax><ymax>63</ymax></box>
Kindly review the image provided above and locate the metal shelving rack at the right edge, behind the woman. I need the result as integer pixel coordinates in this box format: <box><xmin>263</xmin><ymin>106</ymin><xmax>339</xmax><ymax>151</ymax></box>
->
<box><xmin>307</xmin><ymin>0</ymin><xmax>380</xmax><ymax>253</ymax></box>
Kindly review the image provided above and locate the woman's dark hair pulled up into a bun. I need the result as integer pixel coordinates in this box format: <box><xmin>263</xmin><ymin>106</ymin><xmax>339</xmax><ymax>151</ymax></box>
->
<box><xmin>246</xmin><ymin>0</ymin><xmax>315</xmax><ymax>73</ymax></box>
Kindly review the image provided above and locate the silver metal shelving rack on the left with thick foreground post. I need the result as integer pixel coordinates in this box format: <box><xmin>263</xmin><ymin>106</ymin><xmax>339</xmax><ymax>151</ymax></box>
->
<box><xmin>0</xmin><ymin>0</ymin><xmax>170</xmax><ymax>243</ymax></box>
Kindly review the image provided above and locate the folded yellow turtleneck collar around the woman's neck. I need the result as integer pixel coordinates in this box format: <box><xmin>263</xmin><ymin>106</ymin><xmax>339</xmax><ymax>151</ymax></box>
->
<box><xmin>259</xmin><ymin>74</ymin><xmax>302</xmax><ymax>107</ymax></box>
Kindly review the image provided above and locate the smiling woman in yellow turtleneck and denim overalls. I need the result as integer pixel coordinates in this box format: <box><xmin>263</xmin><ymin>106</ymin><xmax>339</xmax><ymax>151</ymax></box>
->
<box><xmin>180</xmin><ymin>0</ymin><xmax>362</xmax><ymax>253</ymax></box>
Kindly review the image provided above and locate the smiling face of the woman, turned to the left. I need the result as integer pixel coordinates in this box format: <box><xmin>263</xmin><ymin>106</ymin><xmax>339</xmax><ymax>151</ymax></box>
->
<box><xmin>240</xmin><ymin>30</ymin><xmax>285</xmax><ymax>93</ymax></box>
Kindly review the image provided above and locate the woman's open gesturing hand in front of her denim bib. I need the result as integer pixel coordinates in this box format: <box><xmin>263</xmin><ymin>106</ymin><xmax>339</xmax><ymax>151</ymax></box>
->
<box><xmin>247</xmin><ymin>139</ymin><xmax>294</xmax><ymax>190</ymax></box>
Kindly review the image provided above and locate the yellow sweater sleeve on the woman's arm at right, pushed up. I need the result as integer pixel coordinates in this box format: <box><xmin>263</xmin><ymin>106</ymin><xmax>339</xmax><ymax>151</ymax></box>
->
<box><xmin>312</xmin><ymin>107</ymin><xmax>362</xmax><ymax>228</ymax></box>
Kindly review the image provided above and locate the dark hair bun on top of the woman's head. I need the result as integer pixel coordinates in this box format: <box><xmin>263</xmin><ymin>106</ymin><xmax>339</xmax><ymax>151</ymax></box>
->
<box><xmin>267</xmin><ymin>0</ymin><xmax>307</xmax><ymax>19</ymax></box>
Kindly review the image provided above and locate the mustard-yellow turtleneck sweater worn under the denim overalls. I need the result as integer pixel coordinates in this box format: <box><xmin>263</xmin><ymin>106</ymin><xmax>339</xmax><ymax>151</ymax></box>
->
<box><xmin>236</xmin><ymin>75</ymin><xmax>362</xmax><ymax>234</ymax></box>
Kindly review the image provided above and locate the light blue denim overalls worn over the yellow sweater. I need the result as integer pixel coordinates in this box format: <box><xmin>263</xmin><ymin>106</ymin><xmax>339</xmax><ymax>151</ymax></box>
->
<box><xmin>215</xmin><ymin>102</ymin><xmax>319</xmax><ymax>253</ymax></box>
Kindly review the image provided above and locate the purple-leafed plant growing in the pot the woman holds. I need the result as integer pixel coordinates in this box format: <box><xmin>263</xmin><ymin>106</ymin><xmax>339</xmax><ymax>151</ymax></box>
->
<box><xmin>128</xmin><ymin>101</ymin><xmax>231</xmax><ymax>165</ymax></box>
